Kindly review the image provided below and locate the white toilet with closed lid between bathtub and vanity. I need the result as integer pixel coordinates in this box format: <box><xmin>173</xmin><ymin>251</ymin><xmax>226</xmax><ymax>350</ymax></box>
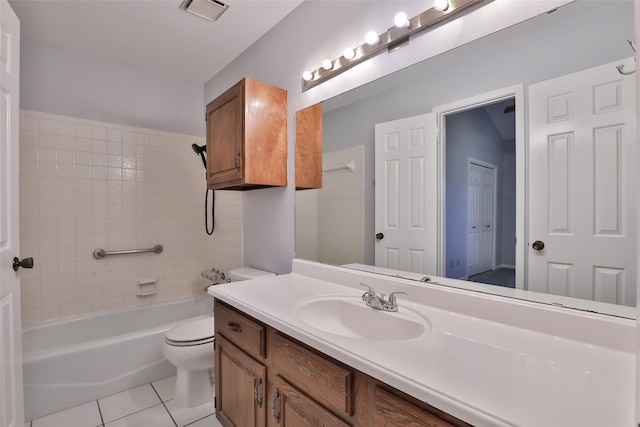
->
<box><xmin>162</xmin><ymin>267</ymin><xmax>274</xmax><ymax>408</ymax></box>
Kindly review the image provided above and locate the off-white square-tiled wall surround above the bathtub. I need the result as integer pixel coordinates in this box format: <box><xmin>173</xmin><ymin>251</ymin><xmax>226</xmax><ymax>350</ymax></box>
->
<box><xmin>20</xmin><ymin>110</ymin><xmax>242</xmax><ymax>325</ymax></box>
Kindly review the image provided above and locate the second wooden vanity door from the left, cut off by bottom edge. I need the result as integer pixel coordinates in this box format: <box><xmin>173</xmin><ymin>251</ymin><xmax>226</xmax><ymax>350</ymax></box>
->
<box><xmin>271</xmin><ymin>376</ymin><xmax>349</xmax><ymax>427</ymax></box>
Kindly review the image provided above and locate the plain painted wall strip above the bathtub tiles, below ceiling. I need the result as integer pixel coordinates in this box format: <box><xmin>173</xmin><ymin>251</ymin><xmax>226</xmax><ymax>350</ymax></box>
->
<box><xmin>20</xmin><ymin>39</ymin><xmax>204</xmax><ymax>136</ymax></box>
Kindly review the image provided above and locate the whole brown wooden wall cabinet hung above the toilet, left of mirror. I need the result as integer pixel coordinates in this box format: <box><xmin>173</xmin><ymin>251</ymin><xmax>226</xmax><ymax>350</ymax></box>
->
<box><xmin>206</xmin><ymin>78</ymin><xmax>287</xmax><ymax>190</ymax></box>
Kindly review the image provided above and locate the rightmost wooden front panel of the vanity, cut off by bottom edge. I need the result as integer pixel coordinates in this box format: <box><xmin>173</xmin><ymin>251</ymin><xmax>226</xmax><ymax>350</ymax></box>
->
<box><xmin>373</xmin><ymin>387</ymin><xmax>455</xmax><ymax>427</ymax></box>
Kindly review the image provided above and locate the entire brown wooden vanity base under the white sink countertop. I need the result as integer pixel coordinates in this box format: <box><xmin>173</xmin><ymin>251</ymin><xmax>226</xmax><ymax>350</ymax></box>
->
<box><xmin>214</xmin><ymin>300</ymin><xmax>469</xmax><ymax>427</ymax></box>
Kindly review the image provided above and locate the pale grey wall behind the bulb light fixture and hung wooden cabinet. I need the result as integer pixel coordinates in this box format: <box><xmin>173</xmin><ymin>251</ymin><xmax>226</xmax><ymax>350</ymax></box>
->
<box><xmin>205</xmin><ymin>0</ymin><xmax>569</xmax><ymax>273</ymax></box>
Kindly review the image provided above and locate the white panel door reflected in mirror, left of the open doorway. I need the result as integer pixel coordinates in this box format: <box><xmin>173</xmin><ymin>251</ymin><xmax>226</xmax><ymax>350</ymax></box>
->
<box><xmin>375</xmin><ymin>114</ymin><xmax>438</xmax><ymax>274</ymax></box>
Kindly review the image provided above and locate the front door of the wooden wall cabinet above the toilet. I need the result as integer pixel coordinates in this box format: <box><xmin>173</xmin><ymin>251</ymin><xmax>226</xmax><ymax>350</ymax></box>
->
<box><xmin>207</xmin><ymin>81</ymin><xmax>244</xmax><ymax>186</ymax></box>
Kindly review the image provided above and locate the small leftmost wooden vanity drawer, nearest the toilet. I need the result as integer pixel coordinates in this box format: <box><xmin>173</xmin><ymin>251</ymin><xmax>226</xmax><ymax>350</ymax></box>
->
<box><xmin>214</xmin><ymin>300</ymin><xmax>266</xmax><ymax>358</ymax></box>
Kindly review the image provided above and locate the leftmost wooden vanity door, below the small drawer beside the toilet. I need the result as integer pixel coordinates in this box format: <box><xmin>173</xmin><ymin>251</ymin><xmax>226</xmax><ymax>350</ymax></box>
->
<box><xmin>216</xmin><ymin>336</ymin><xmax>267</xmax><ymax>427</ymax></box>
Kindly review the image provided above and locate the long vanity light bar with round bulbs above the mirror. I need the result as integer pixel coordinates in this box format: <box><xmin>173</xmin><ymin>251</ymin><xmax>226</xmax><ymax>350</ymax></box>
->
<box><xmin>302</xmin><ymin>0</ymin><xmax>484</xmax><ymax>91</ymax></box>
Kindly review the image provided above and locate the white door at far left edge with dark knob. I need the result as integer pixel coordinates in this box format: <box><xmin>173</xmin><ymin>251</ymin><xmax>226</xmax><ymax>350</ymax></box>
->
<box><xmin>0</xmin><ymin>0</ymin><xmax>24</xmax><ymax>427</ymax></box>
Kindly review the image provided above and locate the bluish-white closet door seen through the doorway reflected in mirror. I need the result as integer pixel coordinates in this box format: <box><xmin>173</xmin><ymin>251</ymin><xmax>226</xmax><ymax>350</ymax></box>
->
<box><xmin>467</xmin><ymin>161</ymin><xmax>496</xmax><ymax>276</ymax></box>
